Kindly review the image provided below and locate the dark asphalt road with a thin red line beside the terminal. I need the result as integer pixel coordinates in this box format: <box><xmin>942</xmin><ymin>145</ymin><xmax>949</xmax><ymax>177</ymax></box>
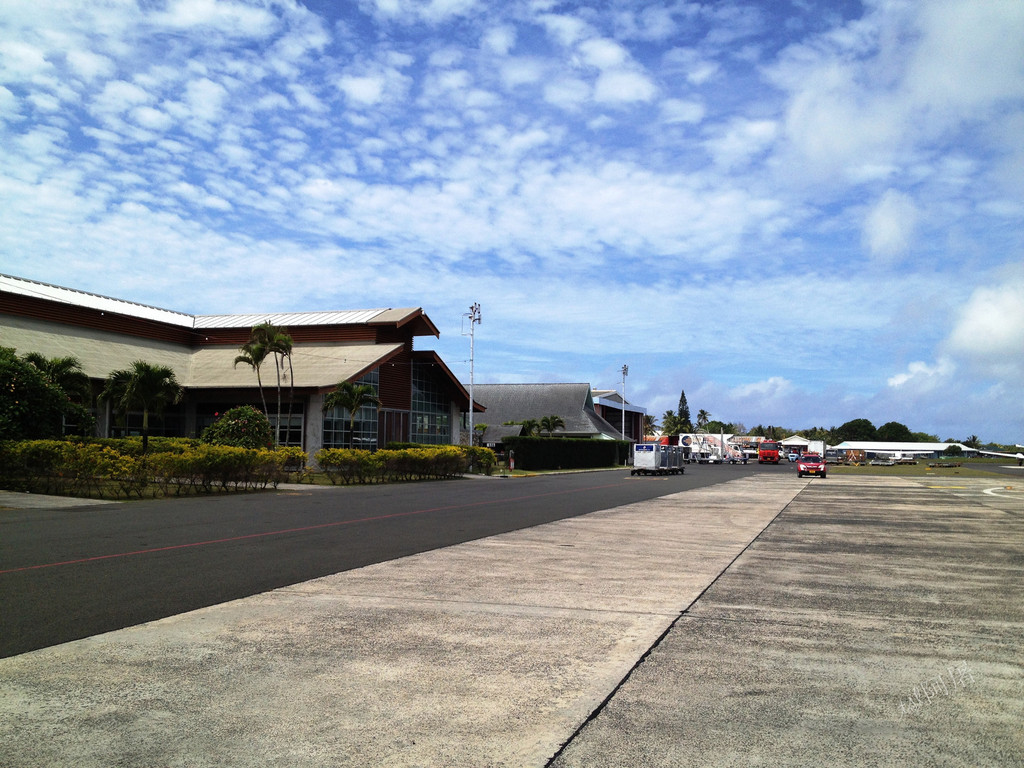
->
<box><xmin>0</xmin><ymin>464</ymin><xmax>792</xmax><ymax>657</ymax></box>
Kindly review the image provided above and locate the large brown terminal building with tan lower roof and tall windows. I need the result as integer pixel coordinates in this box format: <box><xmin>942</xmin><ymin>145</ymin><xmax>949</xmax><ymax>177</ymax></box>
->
<box><xmin>0</xmin><ymin>275</ymin><xmax>484</xmax><ymax>456</ymax></box>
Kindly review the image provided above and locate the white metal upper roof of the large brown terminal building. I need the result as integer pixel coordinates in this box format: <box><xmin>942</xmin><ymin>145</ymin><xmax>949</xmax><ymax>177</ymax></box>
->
<box><xmin>0</xmin><ymin>274</ymin><xmax>418</xmax><ymax>329</ymax></box>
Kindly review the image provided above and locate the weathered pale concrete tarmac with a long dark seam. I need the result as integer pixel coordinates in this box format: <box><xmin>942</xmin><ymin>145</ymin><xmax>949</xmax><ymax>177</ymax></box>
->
<box><xmin>0</xmin><ymin>474</ymin><xmax>1024</xmax><ymax>768</ymax></box>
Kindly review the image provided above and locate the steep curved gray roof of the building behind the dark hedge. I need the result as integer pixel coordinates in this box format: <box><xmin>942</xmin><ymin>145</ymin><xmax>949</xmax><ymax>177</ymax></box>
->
<box><xmin>473</xmin><ymin>384</ymin><xmax>623</xmax><ymax>440</ymax></box>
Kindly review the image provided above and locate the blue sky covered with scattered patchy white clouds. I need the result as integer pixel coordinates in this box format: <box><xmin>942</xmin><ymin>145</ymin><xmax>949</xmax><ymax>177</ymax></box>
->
<box><xmin>0</xmin><ymin>0</ymin><xmax>1024</xmax><ymax>443</ymax></box>
